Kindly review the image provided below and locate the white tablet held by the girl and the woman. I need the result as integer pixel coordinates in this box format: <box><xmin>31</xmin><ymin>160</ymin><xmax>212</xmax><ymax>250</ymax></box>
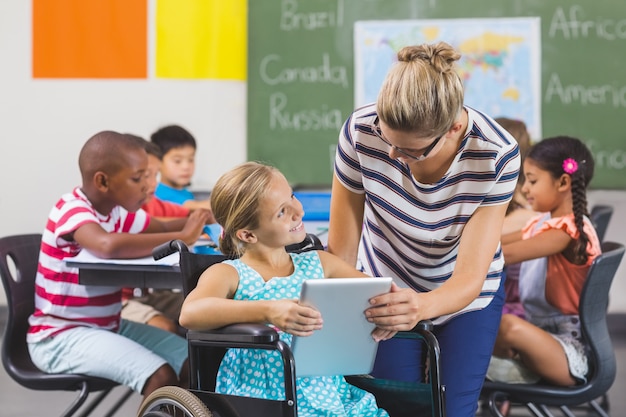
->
<box><xmin>291</xmin><ymin>277</ymin><xmax>392</xmax><ymax>377</ymax></box>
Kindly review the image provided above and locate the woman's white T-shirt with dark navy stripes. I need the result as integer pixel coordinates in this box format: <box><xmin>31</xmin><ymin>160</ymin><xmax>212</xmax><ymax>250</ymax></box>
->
<box><xmin>335</xmin><ymin>104</ymin><xmax>520</xmax><ymax>324</ymax></box>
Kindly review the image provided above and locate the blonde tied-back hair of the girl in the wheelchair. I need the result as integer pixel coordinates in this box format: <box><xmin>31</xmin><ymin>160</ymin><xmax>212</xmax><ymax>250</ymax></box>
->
<box><xmin>211</xmin><ymin>162</ymin><xmax>279</xmax><ymax>257</ymax></box>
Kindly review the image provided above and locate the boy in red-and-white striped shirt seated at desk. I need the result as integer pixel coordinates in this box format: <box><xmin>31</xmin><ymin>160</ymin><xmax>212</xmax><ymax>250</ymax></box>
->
<box><xmin>27</xmin><ymin>131</ymin><xmax>209</xmax><ymax>402</ymax></box>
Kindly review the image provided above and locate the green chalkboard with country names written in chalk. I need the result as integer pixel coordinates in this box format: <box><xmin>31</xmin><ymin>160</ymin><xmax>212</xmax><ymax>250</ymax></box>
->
<box><xmin>247</xmin><ymin>0</ymin><xmax>626</xmax><ymax>189</ymax></box>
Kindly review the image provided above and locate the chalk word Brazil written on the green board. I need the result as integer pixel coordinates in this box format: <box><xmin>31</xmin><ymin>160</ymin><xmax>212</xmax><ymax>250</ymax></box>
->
<box><xmin>280</xmin><ymin>0</ymin><xmax>344</xmax><ymax>31</ymax></box>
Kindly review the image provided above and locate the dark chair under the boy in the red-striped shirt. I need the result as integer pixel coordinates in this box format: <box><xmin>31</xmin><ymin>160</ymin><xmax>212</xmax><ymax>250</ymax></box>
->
<box><xmin>0</xmin><ymin>234</ymin><xmax>133</xmax><ymax>417</ymax></box>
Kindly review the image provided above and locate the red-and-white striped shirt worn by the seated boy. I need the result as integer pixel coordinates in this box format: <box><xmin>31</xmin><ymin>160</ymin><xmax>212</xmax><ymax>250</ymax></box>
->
<box><xmin>27</xmin><ymin>188</ymin><xmax>150</xmax><ymax>343</ymax></box>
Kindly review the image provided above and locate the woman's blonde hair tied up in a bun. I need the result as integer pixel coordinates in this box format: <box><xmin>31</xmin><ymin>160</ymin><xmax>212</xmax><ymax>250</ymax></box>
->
<box><xmin>376</xmin><ymin>42</ymin><xmax>463</xmax><ymax>137</ymax></box>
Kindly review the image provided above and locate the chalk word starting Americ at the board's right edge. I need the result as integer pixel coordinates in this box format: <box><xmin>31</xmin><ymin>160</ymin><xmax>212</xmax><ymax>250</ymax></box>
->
<box><xmin>544</xmin><ymin>73</ymin><xmax>626</xmax><ymax>108</ymax></box>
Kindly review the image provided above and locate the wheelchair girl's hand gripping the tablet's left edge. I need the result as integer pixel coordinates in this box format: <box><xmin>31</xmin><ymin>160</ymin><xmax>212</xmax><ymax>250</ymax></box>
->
<box><xmin>268</xmin><ymin>300</ymin><xmax>323</xmax><ymax>336</ymax></box>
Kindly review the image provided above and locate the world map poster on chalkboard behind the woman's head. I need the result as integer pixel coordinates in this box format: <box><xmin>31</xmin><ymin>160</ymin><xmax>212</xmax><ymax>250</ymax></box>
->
<box><xmin>354</xmin><ymin>17</ymin><xmax>542</xmax><ymax>138</ymax></box>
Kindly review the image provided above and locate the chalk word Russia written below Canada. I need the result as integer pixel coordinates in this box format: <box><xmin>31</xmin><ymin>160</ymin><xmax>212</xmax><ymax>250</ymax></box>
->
<box><xmin>269</xmin><ymin>93</ymin><xmax>343</xmax><ymax>131</ymax></box>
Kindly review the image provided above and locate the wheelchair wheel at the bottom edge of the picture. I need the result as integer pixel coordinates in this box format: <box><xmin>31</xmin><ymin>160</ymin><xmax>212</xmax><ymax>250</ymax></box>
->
<box><xmin>137</xmin><ymin>386</ymin><xmax>213</xmax><ymax>417</ymax></box>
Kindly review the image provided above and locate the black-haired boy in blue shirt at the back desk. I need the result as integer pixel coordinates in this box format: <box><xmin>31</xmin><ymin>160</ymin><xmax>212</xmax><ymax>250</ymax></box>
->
<box><xmin>150</xmin><ymin>125</ymin><xmax>211</xmax><ymax>210</ymax></box>
